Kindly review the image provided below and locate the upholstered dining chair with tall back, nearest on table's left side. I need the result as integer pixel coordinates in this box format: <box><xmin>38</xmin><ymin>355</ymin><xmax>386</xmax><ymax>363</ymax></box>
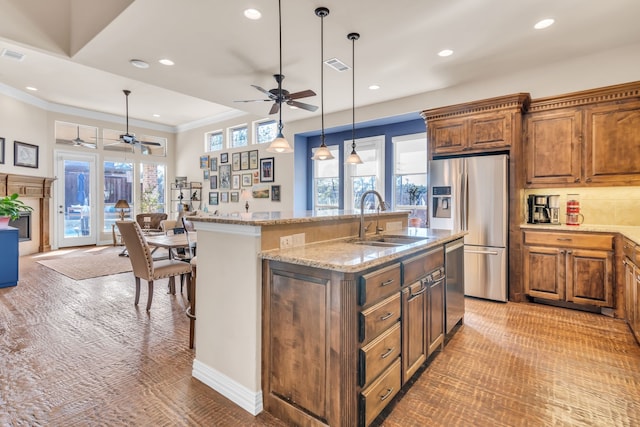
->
<box><xmin>116</xmin><ymin>221</ymin><xmax>191</xmax><ymax>311</ymax></box>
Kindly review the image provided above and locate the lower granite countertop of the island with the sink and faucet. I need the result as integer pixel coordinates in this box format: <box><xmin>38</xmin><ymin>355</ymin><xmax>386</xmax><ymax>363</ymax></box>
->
<box><xmin>260</xmin><ymin>227</ymin><xmax>466</xmax><ymax>273</ymax></box>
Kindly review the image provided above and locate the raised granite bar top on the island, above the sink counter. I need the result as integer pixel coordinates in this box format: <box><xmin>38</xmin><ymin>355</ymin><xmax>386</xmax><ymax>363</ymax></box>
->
<box><xmin>187</xmin><ymin>209</ymin><xmax>409</xmax><ymax>226</ymax></box>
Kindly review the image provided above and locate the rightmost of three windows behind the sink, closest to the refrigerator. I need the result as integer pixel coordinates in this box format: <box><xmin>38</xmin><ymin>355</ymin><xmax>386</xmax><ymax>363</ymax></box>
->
<box><xmin>392</xmin><ymin>133</ymin><xmax>428</xmax><ymax>227</ymax></box>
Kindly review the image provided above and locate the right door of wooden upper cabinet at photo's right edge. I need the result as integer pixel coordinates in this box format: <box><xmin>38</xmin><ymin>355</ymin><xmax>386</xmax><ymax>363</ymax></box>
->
<box><xmin>584</xmin><ymin>102</ymin><xmax>640</xmax><ymax>185</ymax></box>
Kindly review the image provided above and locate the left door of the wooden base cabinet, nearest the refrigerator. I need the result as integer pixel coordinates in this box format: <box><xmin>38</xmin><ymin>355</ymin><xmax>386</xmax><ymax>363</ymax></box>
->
<box><xmin>522</xmin><ymin>246</ymin><xmax>565</xmax><ymax>301</ymax></box>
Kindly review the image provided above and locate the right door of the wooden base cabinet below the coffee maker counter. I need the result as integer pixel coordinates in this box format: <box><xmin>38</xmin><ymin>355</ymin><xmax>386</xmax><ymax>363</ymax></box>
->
<box><xmin>567</xmin><ymin>249</ymin><xmax>614</xmax><ymax>307</ymax></box>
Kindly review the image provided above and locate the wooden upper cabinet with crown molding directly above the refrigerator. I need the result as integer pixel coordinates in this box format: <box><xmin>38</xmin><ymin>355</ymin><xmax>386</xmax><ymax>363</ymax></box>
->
<box><xmin>421</xmin><ymin>93</ymin><xmax>529</xmax><ymax>157</ymax></box>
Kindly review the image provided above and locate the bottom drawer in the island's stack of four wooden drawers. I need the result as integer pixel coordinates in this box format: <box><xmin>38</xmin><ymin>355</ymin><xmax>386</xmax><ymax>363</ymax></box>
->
<box><xmin>359</xmin><ymin>357</ymin><xmax>402</xmax><ymax>426</ymax></box>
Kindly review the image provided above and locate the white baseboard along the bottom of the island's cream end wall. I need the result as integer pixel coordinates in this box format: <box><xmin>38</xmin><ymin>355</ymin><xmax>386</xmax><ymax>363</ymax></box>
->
<box><xmin>191</xmin><ymin>359</ymin><xmax>262</xmax><ymax>416</ymax></box>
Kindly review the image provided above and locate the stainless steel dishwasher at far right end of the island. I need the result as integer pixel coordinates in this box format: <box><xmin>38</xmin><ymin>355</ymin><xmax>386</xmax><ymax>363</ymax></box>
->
<box><xmin>444</xmin><ymin>239</ymin><xmax>464</xmax><ymax>335</ymax></box>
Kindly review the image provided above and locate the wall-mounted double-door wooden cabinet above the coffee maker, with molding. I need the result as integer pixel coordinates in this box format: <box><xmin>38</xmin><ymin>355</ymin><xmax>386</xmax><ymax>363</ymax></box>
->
<box><xmin>524</xmin><ymin>82</ymin><xmax>640</xmax><ymax>188</ymax></box>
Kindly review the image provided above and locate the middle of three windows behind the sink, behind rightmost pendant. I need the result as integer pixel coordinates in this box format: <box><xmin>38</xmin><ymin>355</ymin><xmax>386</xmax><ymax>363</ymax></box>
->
<box><xmin>344</xmin><ymin>135</ymin><xmax>385</xmax><ymax>210</ymax></box>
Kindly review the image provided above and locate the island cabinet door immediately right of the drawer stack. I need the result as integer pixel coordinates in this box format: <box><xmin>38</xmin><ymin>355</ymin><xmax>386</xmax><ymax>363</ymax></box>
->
<box><xmin>402</xmin><ymin>280</ymin><xmax>428</xmax><ymax>384</ymax></box>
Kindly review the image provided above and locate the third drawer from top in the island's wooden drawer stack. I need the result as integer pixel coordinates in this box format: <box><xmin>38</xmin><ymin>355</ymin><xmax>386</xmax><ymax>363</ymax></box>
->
<box><xmin>358</xmin><ymin>322</ymin><xmax>400</xmax><ymax>387</ymax></box>
